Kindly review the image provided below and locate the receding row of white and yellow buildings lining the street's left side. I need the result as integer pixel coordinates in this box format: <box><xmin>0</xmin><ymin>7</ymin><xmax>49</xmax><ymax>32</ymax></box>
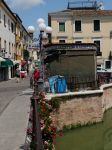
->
<box><xmin>0</xmin><ymin>0</ymin><xmax>31</xmax><ymax>81</ymax></box>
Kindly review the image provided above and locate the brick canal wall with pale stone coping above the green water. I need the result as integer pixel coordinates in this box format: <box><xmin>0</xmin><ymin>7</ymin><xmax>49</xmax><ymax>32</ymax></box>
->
<box><xmin>47</xmin><ymin>84</ymin><xmax>112</xmax><ymax>129</ymax></box>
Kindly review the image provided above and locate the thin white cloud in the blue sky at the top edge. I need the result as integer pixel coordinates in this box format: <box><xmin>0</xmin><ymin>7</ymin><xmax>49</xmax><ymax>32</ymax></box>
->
<box><xmin>6</xmin><ymin>0</ymin><xmax>45</xmax><ymax>9</ymax></box>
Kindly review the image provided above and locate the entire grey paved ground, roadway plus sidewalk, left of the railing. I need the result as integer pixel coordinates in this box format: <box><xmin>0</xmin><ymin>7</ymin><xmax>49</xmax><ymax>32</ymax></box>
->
<box><xmin>0</xmin><ymin>77</ymin><xmax>31</xmax><ymax>150</ymax></box>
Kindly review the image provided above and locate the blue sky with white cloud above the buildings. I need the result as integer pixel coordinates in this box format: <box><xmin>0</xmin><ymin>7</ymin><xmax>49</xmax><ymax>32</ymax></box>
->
<box><xmin>5</xmin><ymin>0</ymin><xmax>112</xmax><ymax>34</ymax></box>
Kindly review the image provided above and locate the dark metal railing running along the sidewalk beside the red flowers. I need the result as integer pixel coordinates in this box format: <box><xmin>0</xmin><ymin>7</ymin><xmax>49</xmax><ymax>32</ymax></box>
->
<box><xmin>24</xmin><ymin>81</ymin><xmax>43</xmax><ymax>150</ymax></box>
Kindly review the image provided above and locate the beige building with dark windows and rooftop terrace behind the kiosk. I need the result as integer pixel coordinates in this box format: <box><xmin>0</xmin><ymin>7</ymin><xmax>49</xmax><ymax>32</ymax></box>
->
<box><xmin>48</xmin><ymin>3</ymin><xmax>112</xmax><ymax>69</ymax></box>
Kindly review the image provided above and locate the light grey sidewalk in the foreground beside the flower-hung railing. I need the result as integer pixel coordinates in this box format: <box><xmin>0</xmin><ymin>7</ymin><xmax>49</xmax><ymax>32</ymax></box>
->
<box><xmin>0</xmin><ymin>95</ymin><xmax>30</xmax><ymax>150</ymax></box>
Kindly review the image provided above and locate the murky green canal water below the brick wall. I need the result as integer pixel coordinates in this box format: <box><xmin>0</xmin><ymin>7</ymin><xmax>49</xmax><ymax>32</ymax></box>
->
<box><xmin>55</xmin><ymin>109</ymin><xmax>112</xmax><ymax>150</ymax></box>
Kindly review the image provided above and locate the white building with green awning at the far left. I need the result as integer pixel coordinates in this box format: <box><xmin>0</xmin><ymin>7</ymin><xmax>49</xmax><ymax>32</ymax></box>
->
<box><xmin>0</xmin><ymin>0</ymin><xmax>16</xmax><ymax>80</ymax></box>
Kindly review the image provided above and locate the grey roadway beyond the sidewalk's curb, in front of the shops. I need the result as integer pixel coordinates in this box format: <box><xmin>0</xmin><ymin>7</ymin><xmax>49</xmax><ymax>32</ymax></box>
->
<box><xmin>0</xmin><ymin>77</ymin><xmax>29</xmax><ymax>115</ymax></box>
